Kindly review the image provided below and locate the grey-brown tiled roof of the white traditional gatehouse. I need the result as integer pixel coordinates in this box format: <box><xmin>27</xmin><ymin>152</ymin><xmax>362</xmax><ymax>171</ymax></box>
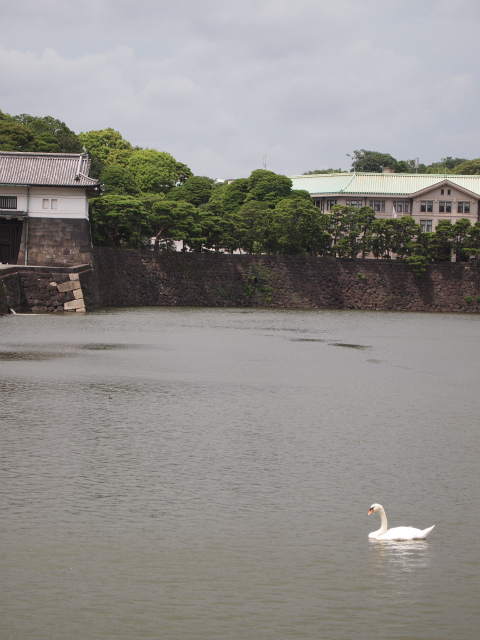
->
<box><xmin>0</xmin><ymin>151</ymin><xmax>100</xmax><ymax>188</ymax></box>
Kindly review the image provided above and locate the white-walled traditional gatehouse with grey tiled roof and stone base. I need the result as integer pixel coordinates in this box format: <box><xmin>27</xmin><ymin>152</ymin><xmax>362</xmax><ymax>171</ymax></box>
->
<box><xmin>0</xmin><ymin>151</ymin><xmax>102</xmax><ymax>266</ymax></box>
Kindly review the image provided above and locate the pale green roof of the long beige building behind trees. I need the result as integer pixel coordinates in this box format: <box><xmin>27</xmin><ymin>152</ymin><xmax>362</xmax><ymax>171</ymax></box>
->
<box><xmin>291</xmin><ymin>173</ymin><xmax>480</xmax><ymax>196</ymax></box>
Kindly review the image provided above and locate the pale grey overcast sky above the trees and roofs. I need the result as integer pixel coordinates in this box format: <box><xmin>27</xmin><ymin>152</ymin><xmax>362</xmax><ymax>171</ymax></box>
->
<box><xmin>0</xmin><ymin>0</ymin><xmax>480</xmax><ymax>178</ymax></box>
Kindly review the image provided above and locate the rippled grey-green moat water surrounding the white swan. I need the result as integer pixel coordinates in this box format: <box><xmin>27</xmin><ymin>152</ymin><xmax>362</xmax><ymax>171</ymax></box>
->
<box><xmin>0</xmin><ymin>309</ymin><xmax>480</xmax><ymax>640</ymax></box>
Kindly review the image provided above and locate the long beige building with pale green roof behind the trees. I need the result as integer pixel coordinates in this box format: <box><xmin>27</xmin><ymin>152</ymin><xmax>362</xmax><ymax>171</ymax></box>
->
<box><xmin>291</xmin><ymin>173</ymin><xmax>480</xmax><ymax>231</ymax></box>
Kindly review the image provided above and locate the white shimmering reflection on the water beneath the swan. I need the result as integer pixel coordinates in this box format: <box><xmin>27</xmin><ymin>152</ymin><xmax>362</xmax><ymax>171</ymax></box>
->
<box><xmin>369</xmin><ymin>540</ymin><xmax>430</xmax><ymax>571</ymax></box>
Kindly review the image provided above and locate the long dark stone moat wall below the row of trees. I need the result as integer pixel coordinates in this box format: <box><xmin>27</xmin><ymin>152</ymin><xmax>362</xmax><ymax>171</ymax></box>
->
<box><xmin>90</xmin><ymin>248</ymin><xmax>480</xmax><ymax>313</ymax></box>
